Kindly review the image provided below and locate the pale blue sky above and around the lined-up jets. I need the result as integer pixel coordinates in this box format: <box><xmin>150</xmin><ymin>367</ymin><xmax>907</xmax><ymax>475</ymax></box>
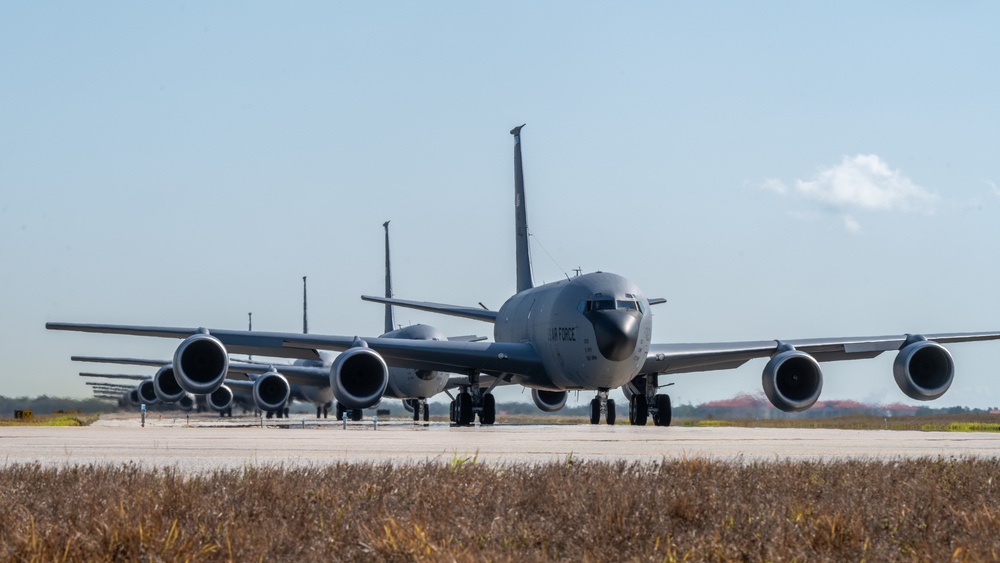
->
<box><xmin>0</xmin><ymin>2</ymin><xmax>1000</xmax><ymax>406</ymax></box>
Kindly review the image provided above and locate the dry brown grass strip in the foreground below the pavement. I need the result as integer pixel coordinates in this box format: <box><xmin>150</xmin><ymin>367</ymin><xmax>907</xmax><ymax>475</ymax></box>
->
<box><xmin>0</xmin><ymin>458</ymin><xmax>1000</xmax><ymax>561</ymax></box>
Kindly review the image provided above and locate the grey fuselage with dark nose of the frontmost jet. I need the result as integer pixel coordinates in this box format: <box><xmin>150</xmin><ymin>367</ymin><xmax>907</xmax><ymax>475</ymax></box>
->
<box><xmin>494</xmin><ymin>272</ymin><xmax>653</xmax><ymax>391</ymax></box>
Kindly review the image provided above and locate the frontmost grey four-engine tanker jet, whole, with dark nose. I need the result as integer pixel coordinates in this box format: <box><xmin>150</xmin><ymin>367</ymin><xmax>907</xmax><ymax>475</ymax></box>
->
<box><xmin>46</xmin><ymin>125</ymin><xmax>1000</xmax><ymax>426</ymax></box>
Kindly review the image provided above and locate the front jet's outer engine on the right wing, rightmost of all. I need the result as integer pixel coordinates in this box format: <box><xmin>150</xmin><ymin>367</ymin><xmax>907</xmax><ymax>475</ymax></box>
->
<box><xmin>892</xmin><ymin>336</ymin><xmax>955</xmax><ymax>401</ymax></box>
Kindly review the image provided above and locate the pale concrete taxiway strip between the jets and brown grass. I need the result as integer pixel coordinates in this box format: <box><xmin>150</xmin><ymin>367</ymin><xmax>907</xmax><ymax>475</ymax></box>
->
<box><xmin>0</xmin><ymin>416</ymin><xmax>1000</xmax><ymax>472</ymax></box>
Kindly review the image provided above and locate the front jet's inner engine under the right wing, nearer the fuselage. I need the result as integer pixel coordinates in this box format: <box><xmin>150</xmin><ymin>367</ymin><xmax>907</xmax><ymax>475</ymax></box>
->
<box><xmin>762</xmin><ymin>350</ymin><xmax>823</xmax><ymax>412</ymax></box>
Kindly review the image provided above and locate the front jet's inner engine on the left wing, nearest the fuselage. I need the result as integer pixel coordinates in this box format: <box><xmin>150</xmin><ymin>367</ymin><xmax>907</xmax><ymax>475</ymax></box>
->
<box><xmin>330</xmin><ymin>344</ymin><xmax>389</xmax><ymax>409</ymax></box>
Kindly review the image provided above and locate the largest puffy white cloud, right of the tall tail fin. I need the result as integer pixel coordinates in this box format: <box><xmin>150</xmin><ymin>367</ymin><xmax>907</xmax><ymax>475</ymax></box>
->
<box><xmin>795</xmin><ymin>154</ymin><xmax>938</xmax><ymax>212</ymax></box>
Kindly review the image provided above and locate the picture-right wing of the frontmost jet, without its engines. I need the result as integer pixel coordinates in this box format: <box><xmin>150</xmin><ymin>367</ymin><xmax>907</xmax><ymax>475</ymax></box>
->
<box><xmin>642</xmin><ymin>332</ymin><xmax>1000</xmax><ymax>375</ymax></box>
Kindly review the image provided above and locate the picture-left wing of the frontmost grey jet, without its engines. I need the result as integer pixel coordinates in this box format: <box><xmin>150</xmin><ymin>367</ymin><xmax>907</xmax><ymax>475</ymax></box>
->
<box><xmin>45</xmin><ymin>323</ymin><xmax>544</xmax><ymax>382</ymax></box>
